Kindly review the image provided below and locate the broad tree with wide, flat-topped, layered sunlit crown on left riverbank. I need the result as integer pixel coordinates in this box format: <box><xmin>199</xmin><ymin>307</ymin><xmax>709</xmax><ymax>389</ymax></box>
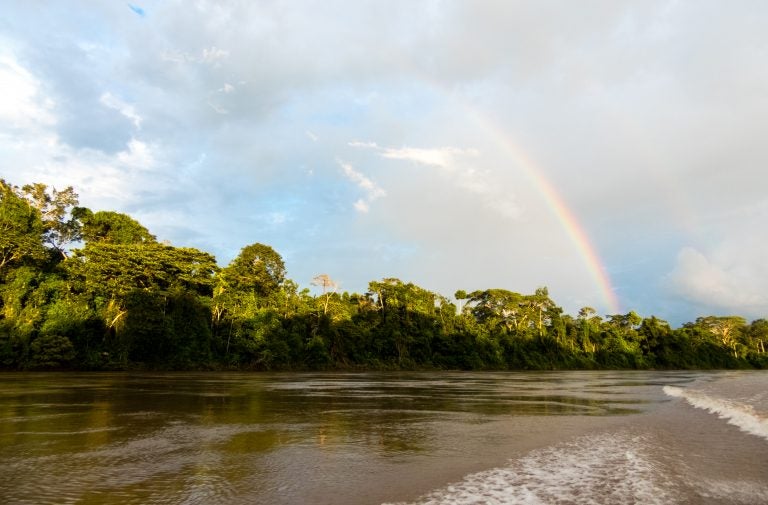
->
<box><xmin>63</xmin><ymin>241</ymin><xmax>218</xmax><ymax>366</ymax></box>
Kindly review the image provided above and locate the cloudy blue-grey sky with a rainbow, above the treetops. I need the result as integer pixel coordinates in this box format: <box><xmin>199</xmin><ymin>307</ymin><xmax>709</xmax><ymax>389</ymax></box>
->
<box><xmin>0</xmin><ymin>0</ymin><xmax>768</xmax><ymax>325</ymax></box>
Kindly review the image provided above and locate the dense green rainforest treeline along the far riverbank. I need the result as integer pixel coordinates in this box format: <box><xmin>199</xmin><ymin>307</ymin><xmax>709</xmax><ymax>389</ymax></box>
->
<box><xmin>0</xmin><ymin>180</ymin><xmax>768</xmax><ymax>370</ymax></box>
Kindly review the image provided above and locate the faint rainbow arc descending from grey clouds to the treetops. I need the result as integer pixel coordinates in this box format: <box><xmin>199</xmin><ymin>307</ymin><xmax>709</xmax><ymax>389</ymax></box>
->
<box><xmin>465</xmin><ymin>106</ymin><xmax>621</xmax><ymax>314</ymax></box>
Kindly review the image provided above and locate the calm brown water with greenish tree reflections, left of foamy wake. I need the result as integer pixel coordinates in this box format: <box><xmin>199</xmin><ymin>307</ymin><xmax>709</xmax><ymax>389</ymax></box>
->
<box><xmin>0</xmin><ymin>372</ymin><xmax>740</xmax><ymax>503</ymax></box>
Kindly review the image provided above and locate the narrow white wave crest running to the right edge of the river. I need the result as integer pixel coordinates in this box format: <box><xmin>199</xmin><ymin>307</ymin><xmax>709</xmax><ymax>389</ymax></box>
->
<box><xmin>664</xmin><ymin>386</ymin><xmax>768</xmax><ymax>440</ymax></box>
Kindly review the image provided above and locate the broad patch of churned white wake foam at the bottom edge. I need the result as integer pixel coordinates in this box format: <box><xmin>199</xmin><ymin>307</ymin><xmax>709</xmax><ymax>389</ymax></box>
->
<box><xmin>388</xmin><ymin>433</ymin><xmax>676</xmax><ymax>505</ymax></box>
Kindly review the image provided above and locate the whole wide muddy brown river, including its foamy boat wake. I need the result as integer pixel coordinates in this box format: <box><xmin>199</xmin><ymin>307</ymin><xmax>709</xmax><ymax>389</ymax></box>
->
<box><xmin>0</xmin><ymin>372</ymin><xmax>768</xmax><ymax>505</ymax></box>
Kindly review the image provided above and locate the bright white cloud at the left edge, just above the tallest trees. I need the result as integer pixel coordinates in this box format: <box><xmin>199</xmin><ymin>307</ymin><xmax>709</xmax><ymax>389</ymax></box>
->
<box><xmin>0</xmin><ymin>58</ymin><xmax>168</xmax><ymax>210</ymax></box>
